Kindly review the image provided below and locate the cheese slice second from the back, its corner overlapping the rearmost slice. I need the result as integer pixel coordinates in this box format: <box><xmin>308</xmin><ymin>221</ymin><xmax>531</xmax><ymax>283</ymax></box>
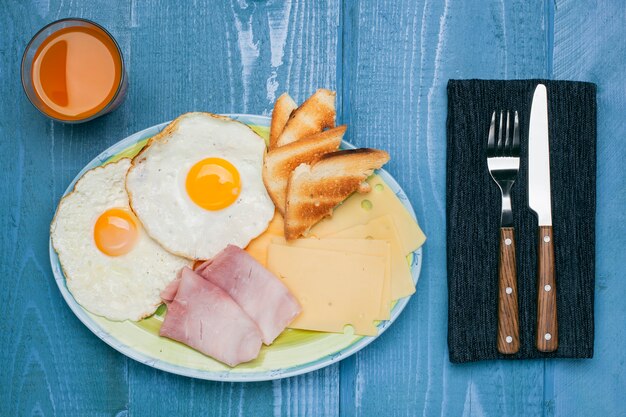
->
<box><xmin>326</xmin><ymin>215</ymin><xmax>415</xmax><ymax>300</ymax></box>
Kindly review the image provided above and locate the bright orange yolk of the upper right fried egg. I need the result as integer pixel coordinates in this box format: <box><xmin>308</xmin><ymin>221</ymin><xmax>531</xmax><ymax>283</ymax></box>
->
<box><xmin>185</xmin><ymin>158</ymin><xmax>241</xmax><ymax>210</ymax></box>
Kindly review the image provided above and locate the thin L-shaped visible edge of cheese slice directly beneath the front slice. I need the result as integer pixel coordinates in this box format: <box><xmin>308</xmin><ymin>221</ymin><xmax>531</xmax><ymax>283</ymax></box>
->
<box><xmin>272</xmin><ymin>238</ymin><xmax>391</xmax><ymax>320</ymax></box>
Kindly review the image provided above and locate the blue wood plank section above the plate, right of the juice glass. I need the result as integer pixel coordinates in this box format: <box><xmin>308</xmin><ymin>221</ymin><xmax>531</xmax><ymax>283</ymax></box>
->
<box><xmin>129</xmin><ymin>0</ymin><xmax>339</xmax><ymax>125</ymax></box>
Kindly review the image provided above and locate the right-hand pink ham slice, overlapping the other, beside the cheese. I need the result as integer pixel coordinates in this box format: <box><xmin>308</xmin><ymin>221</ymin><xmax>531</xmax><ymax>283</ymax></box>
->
<box><xmin>196</xmin><ymin>245</ymin><xmax>301</xmax><ymax>345</ymax></box>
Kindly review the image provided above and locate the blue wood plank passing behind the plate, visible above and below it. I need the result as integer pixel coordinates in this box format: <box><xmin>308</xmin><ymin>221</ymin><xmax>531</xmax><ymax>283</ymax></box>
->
<box><xmin>123</xmin><ymin>0</ymin><xmax>339</xmax><ymax>416</ymax></box>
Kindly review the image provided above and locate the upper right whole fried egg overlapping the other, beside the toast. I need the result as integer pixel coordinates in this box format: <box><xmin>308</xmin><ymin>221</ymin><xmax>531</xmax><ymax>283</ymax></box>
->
<box><xmin>126</xmin><ymin>113</ymin><xmax>274</xmax><ymax>259</ymax></box>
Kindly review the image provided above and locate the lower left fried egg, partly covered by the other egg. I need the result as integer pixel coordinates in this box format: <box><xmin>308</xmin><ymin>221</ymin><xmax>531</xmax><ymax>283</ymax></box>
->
<box><xmin>50</xmin><ymin>158</ymin><xmax>191</xmax><ymax>321</ymax></box>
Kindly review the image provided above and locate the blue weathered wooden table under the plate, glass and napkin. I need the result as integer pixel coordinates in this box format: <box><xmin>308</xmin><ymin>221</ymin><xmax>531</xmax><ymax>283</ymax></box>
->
<box><xmin>0</xmin><ymin>0</ymin><xmax>626</xmax><ymax>417</ymax></box>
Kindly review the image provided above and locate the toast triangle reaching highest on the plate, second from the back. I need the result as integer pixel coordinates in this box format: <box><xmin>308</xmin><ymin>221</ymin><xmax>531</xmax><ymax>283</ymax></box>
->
<box><xmin>276</xmin><ymin>88</ymin><xmax>336</xmax><ymax>147</ymax></box>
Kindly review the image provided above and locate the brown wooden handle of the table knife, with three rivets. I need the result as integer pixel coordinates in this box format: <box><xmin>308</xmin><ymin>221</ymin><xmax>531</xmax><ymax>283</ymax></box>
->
<box><xmin>536</xmin><ymin>226</ymin><xmax>559</xmax><ymax>352</ymax></box>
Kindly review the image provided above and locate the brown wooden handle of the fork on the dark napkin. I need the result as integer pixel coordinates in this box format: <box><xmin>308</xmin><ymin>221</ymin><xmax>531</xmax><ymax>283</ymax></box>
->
<box><xmin>498</xmin><ymin>227</ymin><xmax>519</xmax><ymax>355</ymax></box>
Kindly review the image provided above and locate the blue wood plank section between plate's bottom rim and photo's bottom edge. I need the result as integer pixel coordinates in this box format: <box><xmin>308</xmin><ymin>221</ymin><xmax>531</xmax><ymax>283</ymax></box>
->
<box><xmin>129</xmin><ymin>361</ymin><xmax>339</xmax><ymax>417</ymax></box>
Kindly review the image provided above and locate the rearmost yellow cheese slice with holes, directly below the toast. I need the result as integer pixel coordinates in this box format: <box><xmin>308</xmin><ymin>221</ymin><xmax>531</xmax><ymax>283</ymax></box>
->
<box><xmin>310</xmin><ymin>175</ymin><xmax>426</xmax><ymax>255</ymax></box>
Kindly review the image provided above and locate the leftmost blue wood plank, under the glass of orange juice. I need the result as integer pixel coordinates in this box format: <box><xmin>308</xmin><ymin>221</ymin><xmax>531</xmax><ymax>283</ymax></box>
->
<box><xmin>0</xmin><ymin>1</ymin><xmax>129</xmax><ymax>416</ymax></box>
